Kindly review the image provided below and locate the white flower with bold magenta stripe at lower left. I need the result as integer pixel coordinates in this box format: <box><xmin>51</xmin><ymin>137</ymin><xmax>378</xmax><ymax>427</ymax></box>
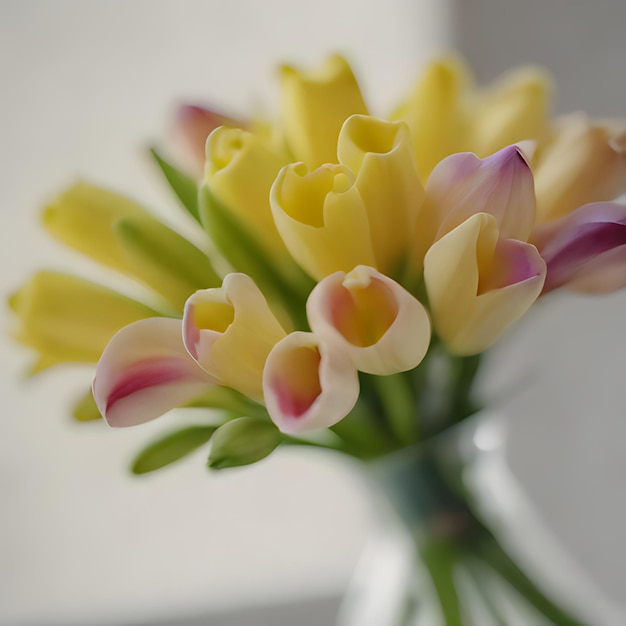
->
<box><xmin>93</xmin><ymin>318</ymin><xmax>216</xmax><ymax>426</ymax></box>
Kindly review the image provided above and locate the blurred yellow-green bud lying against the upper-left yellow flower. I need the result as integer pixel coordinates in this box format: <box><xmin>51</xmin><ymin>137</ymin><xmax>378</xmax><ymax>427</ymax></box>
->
<box><xmin>113</xmin><ymin>217</ymin><xmax>221</xmax><ymax>309</ymax></box>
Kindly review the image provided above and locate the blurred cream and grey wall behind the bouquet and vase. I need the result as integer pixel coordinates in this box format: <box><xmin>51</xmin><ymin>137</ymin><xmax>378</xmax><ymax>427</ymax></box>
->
<box><xmin>0</xmin><ymin>0</ymin><xmax>626</xmax><ymax>626</ymax></box>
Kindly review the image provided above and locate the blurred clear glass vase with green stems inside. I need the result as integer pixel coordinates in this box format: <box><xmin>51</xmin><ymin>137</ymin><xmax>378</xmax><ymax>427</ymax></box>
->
<box><xmin>338</xmin><ymin>414</ymin><xmax>598</xmax><ymax>626</ymax></box>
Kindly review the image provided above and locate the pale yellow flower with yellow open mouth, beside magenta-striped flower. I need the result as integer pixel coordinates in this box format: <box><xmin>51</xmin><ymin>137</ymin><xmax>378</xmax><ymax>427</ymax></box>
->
<box><xmin>183</xmin><ymin>274</ymin><xmax>286</xmax><ymax>401</ymax></box>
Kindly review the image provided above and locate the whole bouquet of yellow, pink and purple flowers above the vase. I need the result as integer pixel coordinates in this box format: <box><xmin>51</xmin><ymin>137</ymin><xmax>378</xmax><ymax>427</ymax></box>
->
<box><xmin>11</xmin><ymin>57</ymin><xmax>626</xmax><ymax>467</ymax></box>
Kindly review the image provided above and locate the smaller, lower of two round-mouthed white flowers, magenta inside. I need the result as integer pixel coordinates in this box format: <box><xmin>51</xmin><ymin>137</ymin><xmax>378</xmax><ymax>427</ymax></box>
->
<box><xmin>263</xmin><ymin>331</ymin><xmax>359</xmax><ymax>433</ymax></box>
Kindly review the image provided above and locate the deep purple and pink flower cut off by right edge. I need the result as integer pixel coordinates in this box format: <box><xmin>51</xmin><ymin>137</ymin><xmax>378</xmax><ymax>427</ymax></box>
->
<box><xmin>536</xmin><ymin>202</ymin><xmax>626</xmax><ymax>293</ymax></box>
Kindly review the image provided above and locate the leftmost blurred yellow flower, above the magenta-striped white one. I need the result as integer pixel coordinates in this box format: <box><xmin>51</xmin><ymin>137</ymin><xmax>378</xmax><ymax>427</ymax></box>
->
<box><xmin>9</xmin><ymin>271</ymin><xmax>158</xmax><ymax>371</ymax></box>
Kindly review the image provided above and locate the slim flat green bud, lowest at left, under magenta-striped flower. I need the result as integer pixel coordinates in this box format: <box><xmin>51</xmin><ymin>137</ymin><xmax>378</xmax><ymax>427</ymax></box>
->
<box><xmin>131</xmin><ymin>426</ymin><xmax>216</xmax><ymax>474</ymax></box>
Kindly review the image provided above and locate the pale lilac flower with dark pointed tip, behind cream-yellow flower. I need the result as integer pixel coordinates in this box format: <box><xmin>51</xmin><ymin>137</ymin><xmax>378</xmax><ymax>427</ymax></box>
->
<box><xmin>426</xmin><ymin>145</ymin><xmax>535</xmax><ymax>241</ymax></box>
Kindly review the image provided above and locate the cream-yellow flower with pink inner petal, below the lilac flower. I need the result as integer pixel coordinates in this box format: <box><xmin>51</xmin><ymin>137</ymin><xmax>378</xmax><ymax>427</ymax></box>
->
<box><xmin>424</xmin><ymin>213</ymin><xmax>546</xmax><ymax>355</ymax></box>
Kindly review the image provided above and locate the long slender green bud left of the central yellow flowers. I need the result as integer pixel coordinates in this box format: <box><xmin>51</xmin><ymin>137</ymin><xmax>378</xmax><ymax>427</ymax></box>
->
<box><xmin>199</xmin><ymin>185</ymin><xmax>315</xmax><ymax>328</ymax></box>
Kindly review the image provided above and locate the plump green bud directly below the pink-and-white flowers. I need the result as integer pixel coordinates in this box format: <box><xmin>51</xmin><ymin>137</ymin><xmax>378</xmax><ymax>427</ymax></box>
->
<box><xmin>209</xmin><ymin>417</ymin><xmax>282</xmax><ymax>469</ymax></box>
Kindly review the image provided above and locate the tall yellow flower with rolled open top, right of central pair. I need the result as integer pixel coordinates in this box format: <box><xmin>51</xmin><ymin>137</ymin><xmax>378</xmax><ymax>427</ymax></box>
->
<box><xmin>337</xmin><ymin>115</ymin><xmax>424</xmax><ymax>276</ymax></box>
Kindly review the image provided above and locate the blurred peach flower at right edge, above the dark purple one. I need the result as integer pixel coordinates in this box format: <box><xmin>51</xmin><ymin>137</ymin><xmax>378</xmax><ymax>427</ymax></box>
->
<box><xmin>533</xmin><ymin>115</ymin><xmax>626</xmax><ymax>224</ymax></box>
